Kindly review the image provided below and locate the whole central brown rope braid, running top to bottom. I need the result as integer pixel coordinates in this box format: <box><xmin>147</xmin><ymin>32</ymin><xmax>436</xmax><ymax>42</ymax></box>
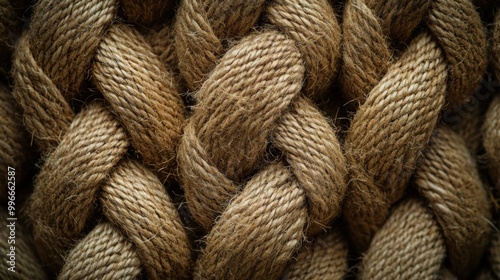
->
<box><xmin>175</xmin><ymin>1</ymin><xmax>346</xmax><ymax>279</ymax></box>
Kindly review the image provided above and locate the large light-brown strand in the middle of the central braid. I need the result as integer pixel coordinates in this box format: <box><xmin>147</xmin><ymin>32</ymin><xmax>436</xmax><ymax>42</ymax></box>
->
<box><xmin>178</xmin><ymin>32</ymin><xmax>304</xmax><ymax>229</ymax></box>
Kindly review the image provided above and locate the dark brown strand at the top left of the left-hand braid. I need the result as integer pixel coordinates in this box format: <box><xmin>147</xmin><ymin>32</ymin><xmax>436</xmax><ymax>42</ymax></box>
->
<box><xmin>13</xmin><ymin>0</ymin><xmax>116</xmax><ymax>154</ymax></box>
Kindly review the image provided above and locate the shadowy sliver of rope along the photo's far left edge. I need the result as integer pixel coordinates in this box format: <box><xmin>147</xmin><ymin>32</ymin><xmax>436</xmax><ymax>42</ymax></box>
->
<box><xmin>0</xmin><ymin>1</ymin><xmax>46</xmax><ymax>279</ymax></box>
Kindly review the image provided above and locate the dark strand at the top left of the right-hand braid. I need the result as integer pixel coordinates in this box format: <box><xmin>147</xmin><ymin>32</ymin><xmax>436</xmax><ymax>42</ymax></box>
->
<box><xmin>340</xmin><ymin>0</ymin><xmax>430</xmax><ymax>107</ymax></box>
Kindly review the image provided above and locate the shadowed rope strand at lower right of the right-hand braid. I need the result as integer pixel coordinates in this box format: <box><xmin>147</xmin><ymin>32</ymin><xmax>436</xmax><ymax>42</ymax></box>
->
<box><xmin>415</xmin><ymin>126</ymin><xmax>491</xmax><ymax>278</ymax></box>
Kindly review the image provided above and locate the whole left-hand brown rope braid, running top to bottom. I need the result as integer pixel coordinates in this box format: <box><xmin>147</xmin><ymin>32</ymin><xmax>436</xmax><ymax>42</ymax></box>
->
<box><xmin>13</xmin><ymin>0</ymin><xmax>190</xmax><ymax>279</ymax></box>
